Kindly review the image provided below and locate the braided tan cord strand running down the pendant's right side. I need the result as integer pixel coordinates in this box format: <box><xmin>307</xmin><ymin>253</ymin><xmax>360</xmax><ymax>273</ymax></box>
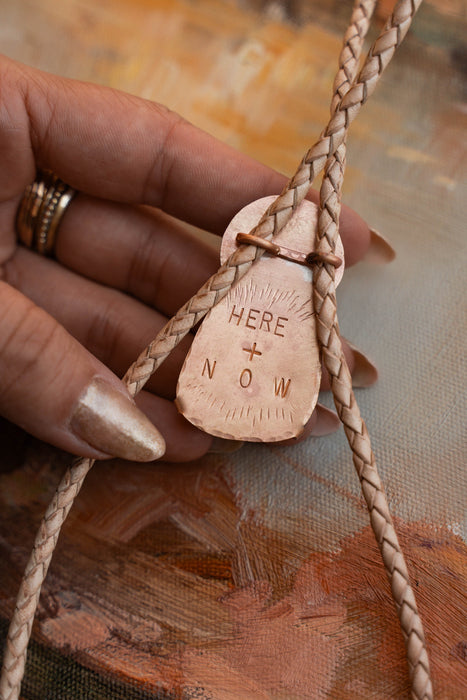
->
<box><xmin>313</xmin><ymin>2</ymin><xmax>433</xmax><ymax>700</ymax></box>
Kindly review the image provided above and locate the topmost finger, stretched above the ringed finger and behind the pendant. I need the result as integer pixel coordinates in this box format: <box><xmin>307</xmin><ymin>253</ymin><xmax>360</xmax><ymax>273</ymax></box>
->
<box><xmin>0</xmin><ymin>59</ymin><xmax>370</xmax><ymax>262</ymax></box>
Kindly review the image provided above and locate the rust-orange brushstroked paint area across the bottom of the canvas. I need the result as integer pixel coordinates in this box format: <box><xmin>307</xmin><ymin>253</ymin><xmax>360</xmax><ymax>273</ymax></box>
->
<box><xmin>0</xmin><ymin>458</ymin><xmax>467</xmax><ymax>700</ymax></box>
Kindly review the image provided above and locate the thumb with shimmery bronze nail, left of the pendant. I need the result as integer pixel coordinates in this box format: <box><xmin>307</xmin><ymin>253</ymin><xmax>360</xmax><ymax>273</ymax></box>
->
<box><xmin>0</xmin><ymin>282</ymin><xmax>165</xmax><ymax>462</ymax></box>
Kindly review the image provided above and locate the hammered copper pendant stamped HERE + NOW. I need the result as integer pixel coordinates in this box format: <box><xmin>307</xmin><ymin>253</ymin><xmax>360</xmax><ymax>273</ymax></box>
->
<box><xmin>176</xmin><ymin>197</ymin><xmax>344</xmax><ymax>442</ymax></box>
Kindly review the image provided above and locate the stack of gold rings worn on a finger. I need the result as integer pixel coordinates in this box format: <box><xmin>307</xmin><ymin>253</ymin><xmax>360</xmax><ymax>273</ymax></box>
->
<box><xmin>16</xmin><ymin>171</ymin><xmax>76</xmax><ymax>256</ymax></box>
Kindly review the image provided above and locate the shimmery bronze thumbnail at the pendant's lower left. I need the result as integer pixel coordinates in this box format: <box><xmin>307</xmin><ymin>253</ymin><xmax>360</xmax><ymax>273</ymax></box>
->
<box><xmin>70</xmin><ymin>378</ymin><xmax>165</xmax><ymax>462</ymax></box>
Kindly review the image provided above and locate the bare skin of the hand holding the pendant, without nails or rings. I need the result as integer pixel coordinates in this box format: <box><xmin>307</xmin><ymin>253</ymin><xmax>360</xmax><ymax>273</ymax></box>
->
<box><xmin>0</xmin><ymin>57</ymin><xmax>370</xmax><ymax>460</ymax></box>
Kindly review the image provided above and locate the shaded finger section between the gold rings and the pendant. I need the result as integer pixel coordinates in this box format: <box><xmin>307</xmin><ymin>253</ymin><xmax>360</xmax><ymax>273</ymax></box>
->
<box><xmin>55</xmin><ymin>195</ymin><xmax>220</xmax><ymax>316</ymax></box>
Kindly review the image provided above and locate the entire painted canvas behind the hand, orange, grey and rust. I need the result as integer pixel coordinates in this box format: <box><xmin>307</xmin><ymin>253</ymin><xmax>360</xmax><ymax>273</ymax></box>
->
<box><xmin>0</xmin><ymin>0</ymin><xmax>467</xmax><ymax>700</ymax></box>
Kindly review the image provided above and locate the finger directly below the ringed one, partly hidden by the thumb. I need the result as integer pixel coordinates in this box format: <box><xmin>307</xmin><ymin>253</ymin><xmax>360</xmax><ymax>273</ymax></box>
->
<box><xmin>5</xmin><ymin>248</ymin><xmax>191</xmax><ymax>399</ymax></box>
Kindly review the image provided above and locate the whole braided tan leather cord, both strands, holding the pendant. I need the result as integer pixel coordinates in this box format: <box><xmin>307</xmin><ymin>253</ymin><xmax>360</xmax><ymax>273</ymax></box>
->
<box><xmin>0</xmin><ymin>0</ymin><xmax>432</xmax><ymax>700</ymax></box>
